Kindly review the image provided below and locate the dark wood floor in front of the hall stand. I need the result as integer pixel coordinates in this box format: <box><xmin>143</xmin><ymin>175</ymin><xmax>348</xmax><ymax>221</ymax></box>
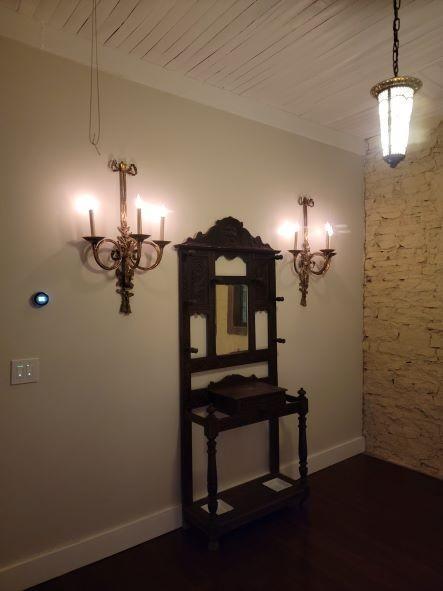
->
<box><xmin>28</xmin><ymin>455</ymin><xmax>443</xmax><ymax>591</ymax></box>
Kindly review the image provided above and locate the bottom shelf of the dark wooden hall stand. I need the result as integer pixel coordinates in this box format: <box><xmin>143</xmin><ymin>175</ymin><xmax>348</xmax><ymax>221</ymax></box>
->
<box><xmin>183</xmin><ymin>473</ymin><xmax>307</xmax><ymax>537</ymax></box>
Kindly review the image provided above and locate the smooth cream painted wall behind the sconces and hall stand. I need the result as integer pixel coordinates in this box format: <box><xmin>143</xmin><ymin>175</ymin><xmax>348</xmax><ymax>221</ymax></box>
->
<box><xmin>0</xmin><ymin>39</ymin><xmax>363</xmax><ymax>588</ymax></box>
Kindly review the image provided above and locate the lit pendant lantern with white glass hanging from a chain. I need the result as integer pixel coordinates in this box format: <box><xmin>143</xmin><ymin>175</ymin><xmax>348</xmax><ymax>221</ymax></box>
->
<box><xmin>371</xmin><ymin>0</ymin><xmax>422</xmax><ymax>168</ymax></box>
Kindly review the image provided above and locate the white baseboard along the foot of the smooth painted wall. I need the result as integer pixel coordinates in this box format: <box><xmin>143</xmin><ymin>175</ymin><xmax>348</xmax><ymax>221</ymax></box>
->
<box><xmin>0</xmin><ymin>437</ymin><xmax>365</xmax><ymax>591</ymax></box>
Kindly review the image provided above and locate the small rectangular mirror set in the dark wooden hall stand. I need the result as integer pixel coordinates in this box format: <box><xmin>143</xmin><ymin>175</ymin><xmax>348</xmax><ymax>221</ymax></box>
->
<box><xmin>215</xmin><ymin>283</ymin><xmax>249</xmax><ymax>355</ymax></box>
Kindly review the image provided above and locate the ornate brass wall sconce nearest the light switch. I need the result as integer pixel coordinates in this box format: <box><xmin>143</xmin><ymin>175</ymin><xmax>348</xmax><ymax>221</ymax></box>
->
<box><xmin>83</xmin><ymin>160</ymin><xmax>169</xmax><ymax>314</ymax></box>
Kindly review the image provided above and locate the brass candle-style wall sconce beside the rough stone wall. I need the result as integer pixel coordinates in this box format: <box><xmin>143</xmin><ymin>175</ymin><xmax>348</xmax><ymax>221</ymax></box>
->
<box><xmin>289</xmin><ymin>195</ymin><xmax>336</xmax><ymax>306</ymax></box>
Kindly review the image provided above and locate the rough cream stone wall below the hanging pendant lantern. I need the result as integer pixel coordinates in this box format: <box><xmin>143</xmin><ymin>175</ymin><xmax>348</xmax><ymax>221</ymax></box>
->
<box><xmin>363</xmin><ymin>122</ymin><xmax>443</xmax><ymax>477</ymax></box>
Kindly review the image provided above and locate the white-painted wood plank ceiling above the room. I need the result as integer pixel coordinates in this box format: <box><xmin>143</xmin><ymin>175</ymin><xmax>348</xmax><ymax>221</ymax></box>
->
<box><xmin>0</xmin><ymin>0</ymin><xmax>443</xmax><ymax>138</ymax></box>
